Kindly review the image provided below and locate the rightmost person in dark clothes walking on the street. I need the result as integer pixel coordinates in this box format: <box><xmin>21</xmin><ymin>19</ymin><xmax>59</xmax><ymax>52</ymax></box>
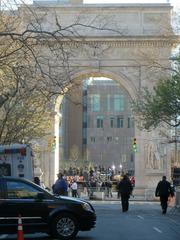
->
<box><xmin>155</xmin><ymin>176</ymin><xmax>174</xmax><ymax>214</ymax></box>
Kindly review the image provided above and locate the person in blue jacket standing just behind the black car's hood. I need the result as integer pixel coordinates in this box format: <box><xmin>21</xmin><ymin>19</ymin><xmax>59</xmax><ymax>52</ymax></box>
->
<box><xmin>52</xmin><ymin>173</ymin><xmax>68</xmax><ymax>196</ymax></box>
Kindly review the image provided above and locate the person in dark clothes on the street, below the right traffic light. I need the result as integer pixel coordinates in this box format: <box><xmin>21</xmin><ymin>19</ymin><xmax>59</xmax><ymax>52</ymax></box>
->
<box><xmin>118</xmin><ymin>175</ymin><xmax>133</xmax><ymax>212</ymax></box>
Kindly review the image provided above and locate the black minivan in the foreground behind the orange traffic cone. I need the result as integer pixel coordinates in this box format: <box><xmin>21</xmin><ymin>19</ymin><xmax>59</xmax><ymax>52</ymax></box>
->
<box><xmin>0</xmin><ymin>177</ymin><xmax>96</xmax><ymax>240</ymax></box>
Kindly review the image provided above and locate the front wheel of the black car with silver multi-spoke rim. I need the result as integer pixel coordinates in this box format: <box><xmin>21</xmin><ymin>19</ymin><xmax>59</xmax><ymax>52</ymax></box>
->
<box><xmin>52</xmin><ymin>213</ymin><xmax>78</xmax><ymax>240</ymax></box>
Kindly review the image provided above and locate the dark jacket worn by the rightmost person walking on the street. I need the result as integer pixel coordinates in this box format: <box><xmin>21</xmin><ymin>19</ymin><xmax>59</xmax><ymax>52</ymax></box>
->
<box><xmin>155</xmin><ymin>180</ymin><xmax>174</xmax><ymax>197</ymax></box>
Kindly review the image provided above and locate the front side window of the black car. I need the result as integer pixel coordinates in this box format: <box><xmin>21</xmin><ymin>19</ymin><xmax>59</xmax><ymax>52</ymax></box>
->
<box><xmin>7</xmin><ymin>181</ymin><xmax>39</xmax><ymax>199</ymax></box>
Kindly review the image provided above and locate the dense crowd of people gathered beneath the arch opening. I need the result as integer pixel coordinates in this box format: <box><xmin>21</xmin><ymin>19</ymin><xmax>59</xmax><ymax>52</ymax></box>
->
<box><xmin>49</xmin><ymin>166</ymin><xmax>135</xmax><ymax>201</ymax></box>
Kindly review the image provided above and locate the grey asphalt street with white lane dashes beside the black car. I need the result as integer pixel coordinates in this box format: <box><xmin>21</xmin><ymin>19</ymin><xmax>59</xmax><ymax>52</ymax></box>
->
<box><xmin>0</xmin><ymin>201</ymin><xmax>180</xmax><ymax>240</ymax></box>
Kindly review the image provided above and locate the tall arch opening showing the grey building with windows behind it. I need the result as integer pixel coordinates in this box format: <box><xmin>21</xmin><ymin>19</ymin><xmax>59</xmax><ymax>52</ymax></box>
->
<box><xmin>54</xmin><ymin>72</ymin><xmax>135</xmax><ymax>184</ymax></box>
